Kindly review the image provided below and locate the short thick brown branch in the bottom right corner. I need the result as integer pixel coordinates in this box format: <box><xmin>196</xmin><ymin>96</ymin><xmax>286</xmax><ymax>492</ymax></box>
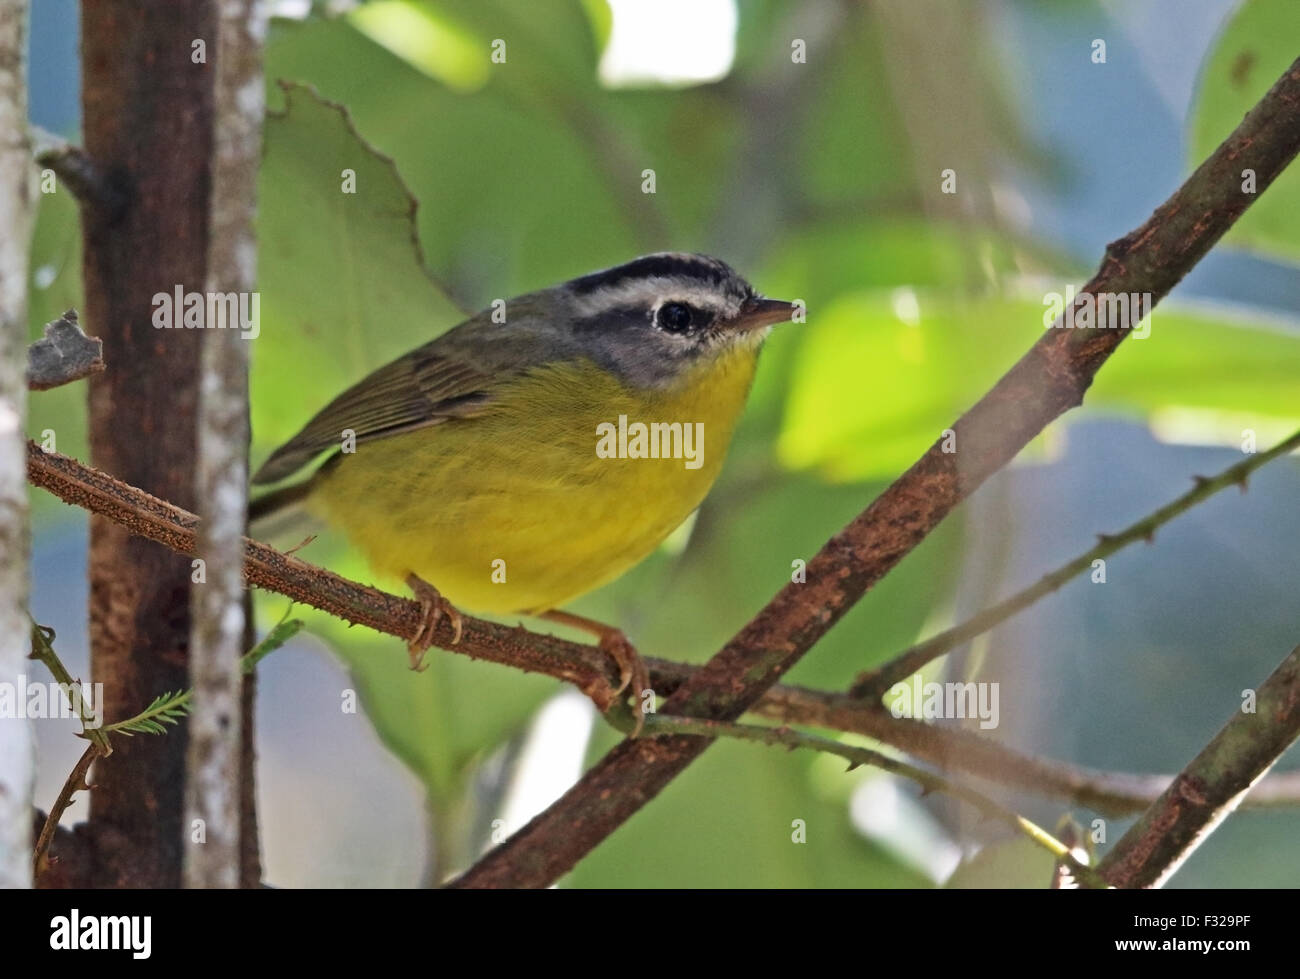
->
<box><xmin>1097</xmin><ymin>646</ymin><xmax>1300</xmax><ymax>887</ymax></box>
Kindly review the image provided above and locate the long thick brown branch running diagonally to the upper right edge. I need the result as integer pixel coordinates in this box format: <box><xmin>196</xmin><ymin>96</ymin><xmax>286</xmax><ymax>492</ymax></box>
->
<box><xmin>454</xmin><ymin>60</ymin><xmax>1300</xmax><ymax>887</ymax></box>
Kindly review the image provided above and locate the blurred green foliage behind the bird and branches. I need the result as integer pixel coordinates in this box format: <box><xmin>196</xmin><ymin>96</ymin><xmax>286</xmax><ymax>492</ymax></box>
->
<box><xmin>30</xmin><ymin>0</ymin><xmax>1300</xmax><ymax>887</ymax></box>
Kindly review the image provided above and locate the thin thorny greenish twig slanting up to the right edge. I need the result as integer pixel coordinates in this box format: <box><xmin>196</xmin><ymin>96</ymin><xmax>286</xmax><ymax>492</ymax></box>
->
<box><xmin>849</xmin><ymin>432</ymin><xmax>1300</xmax><ymax>697</ymax></box>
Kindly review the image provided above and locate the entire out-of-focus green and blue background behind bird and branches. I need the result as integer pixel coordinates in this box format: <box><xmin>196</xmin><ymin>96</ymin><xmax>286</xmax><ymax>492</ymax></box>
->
<box><xmin>29</xmin><ymin>0</ymin><xmax>1300</xmax><ymax>887</ymax></box>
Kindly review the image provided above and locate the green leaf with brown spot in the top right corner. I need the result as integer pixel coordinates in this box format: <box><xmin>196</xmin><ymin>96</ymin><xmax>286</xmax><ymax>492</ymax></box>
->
<box><xmin>1191</xmin><ymin>0</ymin><xmax>1300</xmax><ymax>263</ymax></box>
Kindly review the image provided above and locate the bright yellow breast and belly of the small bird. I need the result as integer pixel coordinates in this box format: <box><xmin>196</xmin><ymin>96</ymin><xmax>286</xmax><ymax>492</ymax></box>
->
<box><xmin>308</xmin><ymin>350</ymin><xmax>757</xmax><ymax>614</ymax></box>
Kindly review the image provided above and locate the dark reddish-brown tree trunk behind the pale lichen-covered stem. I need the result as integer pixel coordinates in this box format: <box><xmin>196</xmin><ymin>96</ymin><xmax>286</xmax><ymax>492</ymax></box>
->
<box><xmin>82</xmin><ymin>0</ymin><xmax>256</xmax><ymax>887</ymax></box>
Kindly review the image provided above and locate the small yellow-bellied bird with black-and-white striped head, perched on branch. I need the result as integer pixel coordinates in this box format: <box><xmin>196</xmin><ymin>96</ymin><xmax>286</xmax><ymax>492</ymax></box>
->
<box><xmin>250</xmin><ymin>252</ymin><xmax>796</xmax><ymax>727</ymax></box>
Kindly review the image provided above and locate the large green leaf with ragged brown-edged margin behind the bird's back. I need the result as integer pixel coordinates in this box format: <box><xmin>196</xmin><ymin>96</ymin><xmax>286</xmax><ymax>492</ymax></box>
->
<box><xmin>251</xmin><ymin>79</ymin><xmax>463</xmax><ymax>449</ymax></box>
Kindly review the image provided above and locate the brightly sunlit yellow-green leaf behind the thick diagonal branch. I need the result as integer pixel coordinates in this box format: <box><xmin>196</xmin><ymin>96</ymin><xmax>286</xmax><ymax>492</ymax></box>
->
<box><xmin>779</xmin><ymin>290</ymin><xmax>1300</xmax><ymax>480</ymax></box>
